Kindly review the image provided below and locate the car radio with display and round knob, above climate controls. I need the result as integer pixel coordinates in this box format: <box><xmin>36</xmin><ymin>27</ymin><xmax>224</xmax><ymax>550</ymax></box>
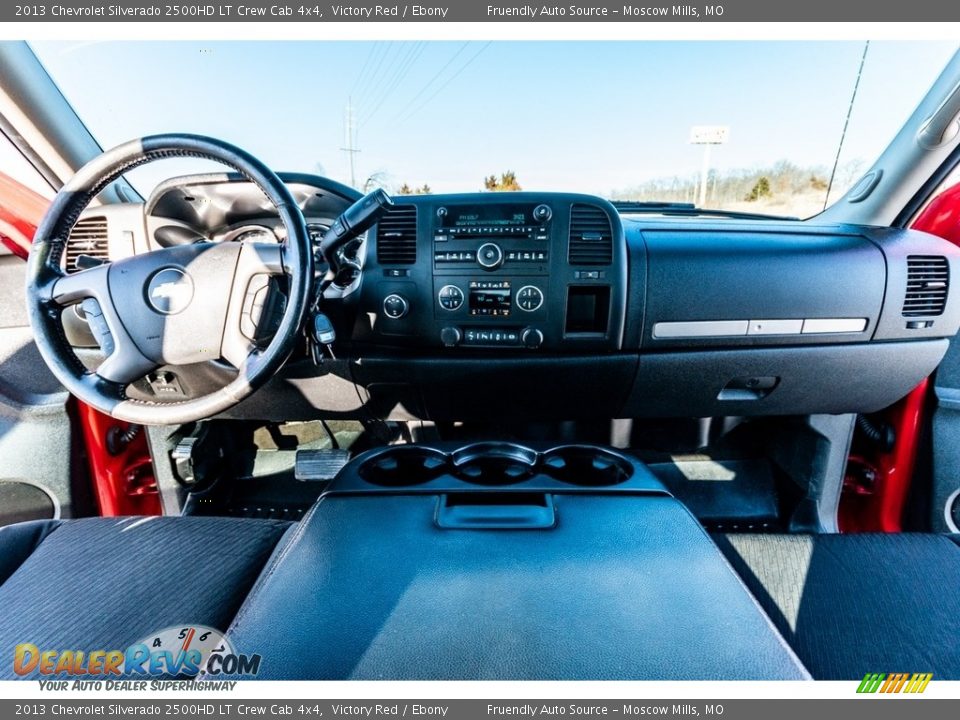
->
<box><xmin>433</xmin><ymin>203</ymin><xmax>553</xmax><ymax>275</ymax></box>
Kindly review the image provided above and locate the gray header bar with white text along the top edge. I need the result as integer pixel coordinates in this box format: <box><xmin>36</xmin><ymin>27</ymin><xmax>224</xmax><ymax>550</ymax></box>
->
<box><xmin>0</xmin><ymin>0</ymin><xmax>960</xmax><ymax>23</ymax></box>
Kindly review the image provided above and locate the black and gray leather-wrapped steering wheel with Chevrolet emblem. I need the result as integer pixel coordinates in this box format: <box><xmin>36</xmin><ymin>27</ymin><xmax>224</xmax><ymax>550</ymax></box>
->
<box><xmin>27</xmin><ymin>134</ymin><xmax>313</xmax><ymax>424</ymax></box>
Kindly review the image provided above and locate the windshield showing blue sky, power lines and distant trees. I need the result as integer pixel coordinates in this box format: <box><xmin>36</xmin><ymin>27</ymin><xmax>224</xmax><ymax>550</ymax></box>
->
<box><xmin>33</xmin><ymin>41</ymin><xmax>957</xmax><ymax>217</ymax></box>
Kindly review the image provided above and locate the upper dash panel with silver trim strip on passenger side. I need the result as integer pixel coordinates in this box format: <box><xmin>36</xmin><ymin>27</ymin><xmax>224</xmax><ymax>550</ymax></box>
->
<box><xmin>643</xmin><ymin>229</ymin><xmax>886</xmax><ymax>348</ymax></box>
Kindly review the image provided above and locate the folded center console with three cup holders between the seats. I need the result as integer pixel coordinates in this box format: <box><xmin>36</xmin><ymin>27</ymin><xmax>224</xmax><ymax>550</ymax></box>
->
<box><xmin>228</xmin><ymin>442</ymin><xmax>809</xmax><ymax>680</ymax></box>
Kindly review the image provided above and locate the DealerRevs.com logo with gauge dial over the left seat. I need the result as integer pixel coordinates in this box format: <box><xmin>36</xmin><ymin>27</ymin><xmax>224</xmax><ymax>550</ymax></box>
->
<box><xmin>13</xmin><ymin>625</ymin><xmax>261</xmax><ymax>679</ymax></box>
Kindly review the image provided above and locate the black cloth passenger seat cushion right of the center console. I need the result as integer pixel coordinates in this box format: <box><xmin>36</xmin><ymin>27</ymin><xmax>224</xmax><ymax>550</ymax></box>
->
<box><xmin>714</xmin><ymin>534</ymin><xmax>960</xmax><ymax>680</ymax></box>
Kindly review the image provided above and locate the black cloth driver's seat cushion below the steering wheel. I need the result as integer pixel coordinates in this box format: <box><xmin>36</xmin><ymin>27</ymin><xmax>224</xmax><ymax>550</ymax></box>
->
<box><xmin>0</xmin><ymin>517</ymin><xmax>289</xmax><ymax>679</ymax></box>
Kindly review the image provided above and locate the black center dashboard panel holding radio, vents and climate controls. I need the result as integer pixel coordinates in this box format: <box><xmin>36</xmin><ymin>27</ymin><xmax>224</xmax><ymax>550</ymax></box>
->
<box><xmin>355</xmin><ymin>193</ymin><xmax>627</xmax><ymax>352</ymax></box>
